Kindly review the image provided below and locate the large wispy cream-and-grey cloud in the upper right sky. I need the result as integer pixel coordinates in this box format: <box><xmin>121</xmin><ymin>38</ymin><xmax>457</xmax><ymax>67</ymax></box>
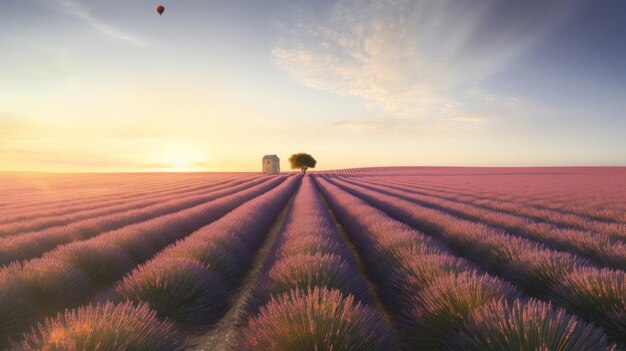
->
<box><xmin>272</xmin><ymin>0</ymin><xmax>574</xmax><ymax>128</ymax></box>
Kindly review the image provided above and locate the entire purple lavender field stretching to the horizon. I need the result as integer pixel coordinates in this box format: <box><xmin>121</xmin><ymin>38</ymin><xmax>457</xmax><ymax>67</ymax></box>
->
<box><xmin>0</xmin><ymin>167</ymin><xmax>626</xmax><ymax>351</ymax></box>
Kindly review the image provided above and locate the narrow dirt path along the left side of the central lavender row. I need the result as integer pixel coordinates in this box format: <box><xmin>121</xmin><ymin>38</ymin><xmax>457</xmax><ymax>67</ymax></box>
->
<box><xmin>187</xmin><ymin>186</ymin><xmax>300</xmax><ymax>351</ymax></box>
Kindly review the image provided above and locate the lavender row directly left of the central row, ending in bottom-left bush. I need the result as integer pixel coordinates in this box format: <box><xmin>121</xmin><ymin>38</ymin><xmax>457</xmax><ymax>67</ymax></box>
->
<box><xmin>15</xmin><ymin>177</ymin><xmax>299</xmax><ymax>350</ymax></box>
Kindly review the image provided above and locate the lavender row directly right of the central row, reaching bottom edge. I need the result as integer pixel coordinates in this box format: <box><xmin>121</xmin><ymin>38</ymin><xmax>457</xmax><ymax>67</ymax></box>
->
<box><xmin>317</xmin><ymin>178</ymin><xmax>609</xmax><ymax>351</ymax></box>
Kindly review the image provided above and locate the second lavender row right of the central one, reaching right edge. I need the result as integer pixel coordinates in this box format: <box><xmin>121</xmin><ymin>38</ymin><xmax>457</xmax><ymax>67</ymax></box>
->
<box><xmin>324</xmin><ymin>180</ymin><xmax>626</xmax><ymax>343</ymax></box>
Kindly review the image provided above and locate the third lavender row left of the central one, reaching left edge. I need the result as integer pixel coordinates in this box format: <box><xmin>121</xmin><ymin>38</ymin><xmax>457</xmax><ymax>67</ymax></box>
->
<box><xmin>0</xmin><ymin>178</ymin><xmax>267</xmax><ymax>265</ymax></box>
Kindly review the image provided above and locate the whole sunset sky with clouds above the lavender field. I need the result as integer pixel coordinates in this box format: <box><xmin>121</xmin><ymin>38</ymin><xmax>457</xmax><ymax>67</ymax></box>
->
<box><xmin>0</xmin><ymin>0</ymin><xmax>626</xmax><ymax>172</ymax></box>
